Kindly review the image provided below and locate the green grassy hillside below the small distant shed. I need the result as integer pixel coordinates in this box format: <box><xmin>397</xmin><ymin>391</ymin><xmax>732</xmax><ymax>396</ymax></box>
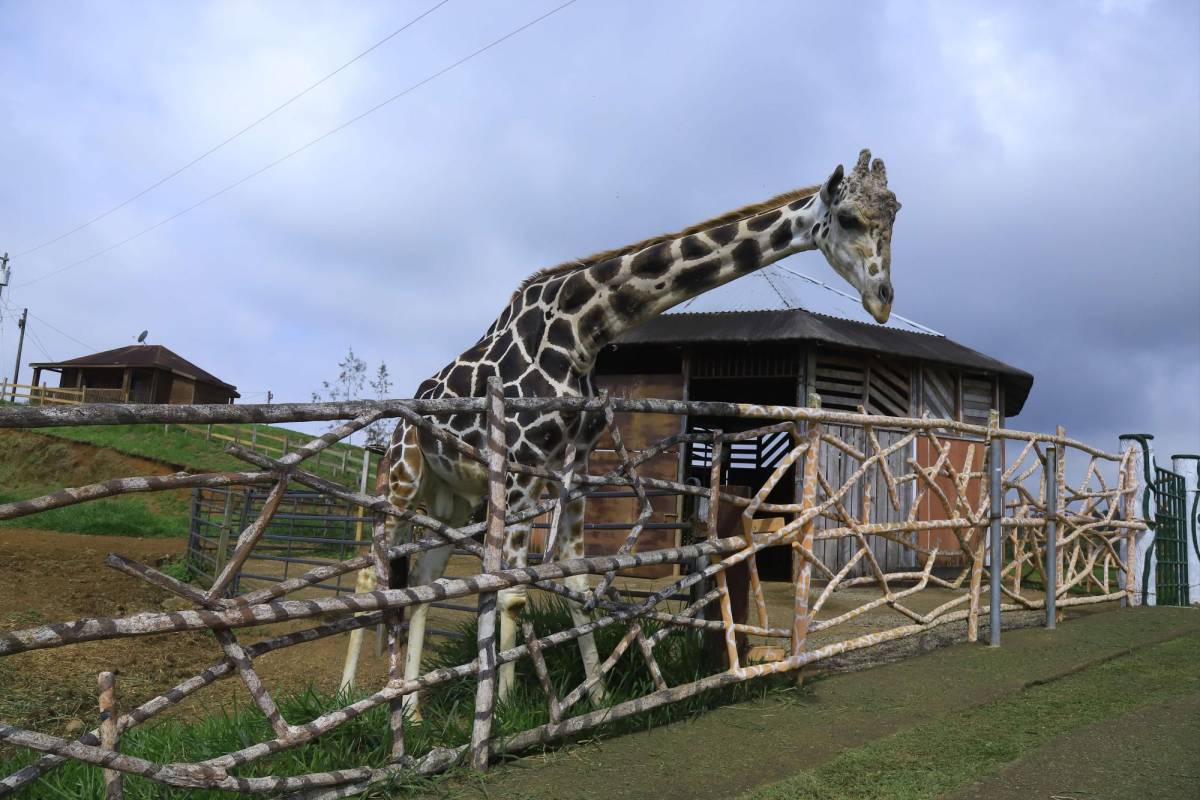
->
<box><xmin>0</xmin><ymin>425</ymin><xmax>378</xmax><ymax>536</ymax></box>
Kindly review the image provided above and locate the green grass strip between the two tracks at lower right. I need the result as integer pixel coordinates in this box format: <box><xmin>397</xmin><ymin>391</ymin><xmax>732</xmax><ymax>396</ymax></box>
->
<box><xmin>743</xmin><ymin>636</ymin><xmax>1200</xmax><ymax>800</ymax></box>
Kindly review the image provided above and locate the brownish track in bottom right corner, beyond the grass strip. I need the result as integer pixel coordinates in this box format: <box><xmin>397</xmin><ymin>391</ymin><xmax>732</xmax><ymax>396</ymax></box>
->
<box><xmin>952</xmin><ymin>694</ymin><xmax>1200</xmax><ymax>800</ymax></box>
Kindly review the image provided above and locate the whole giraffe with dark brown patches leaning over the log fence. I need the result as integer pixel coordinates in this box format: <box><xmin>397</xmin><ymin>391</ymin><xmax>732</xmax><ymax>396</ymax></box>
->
<box><xmin>342</xmin><ymin>150</ymin><xmax>900</xmax><ymax>720</ymax></box>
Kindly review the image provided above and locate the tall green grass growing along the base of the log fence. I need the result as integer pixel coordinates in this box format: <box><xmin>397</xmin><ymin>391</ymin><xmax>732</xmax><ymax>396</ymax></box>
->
<box><xmin>0</xmin><ymin>599</ymin><xmax>763</xmax><ymax>800</ymax></box>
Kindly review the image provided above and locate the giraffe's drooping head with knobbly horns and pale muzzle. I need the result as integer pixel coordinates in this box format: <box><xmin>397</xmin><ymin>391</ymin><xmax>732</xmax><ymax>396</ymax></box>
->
<box><xmin>816</xmin><ymin>150</ymin><xmax>900</xmax><ymax>324</ymax></box>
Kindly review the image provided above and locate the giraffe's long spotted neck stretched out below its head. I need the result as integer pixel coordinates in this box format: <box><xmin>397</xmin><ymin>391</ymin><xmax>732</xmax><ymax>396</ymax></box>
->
<box><xmin>557</xmin><ymin>194</ymin><xmax>828</xmax><ymax>374</ymax></box>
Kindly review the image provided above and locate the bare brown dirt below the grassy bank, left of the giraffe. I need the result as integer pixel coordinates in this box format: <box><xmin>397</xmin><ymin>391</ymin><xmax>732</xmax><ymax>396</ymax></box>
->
<box><xmin>0</xmin><ymin>528</ymin><xmax>400</xmax><ymax>733</ymax></box>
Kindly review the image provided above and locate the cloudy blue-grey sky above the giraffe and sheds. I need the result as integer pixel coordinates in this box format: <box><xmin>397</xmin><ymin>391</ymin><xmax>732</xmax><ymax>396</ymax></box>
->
<box><xmin>0</xmin><ymin>0</ymin><xmax>1200</xmax><ymax>455</ymax></box>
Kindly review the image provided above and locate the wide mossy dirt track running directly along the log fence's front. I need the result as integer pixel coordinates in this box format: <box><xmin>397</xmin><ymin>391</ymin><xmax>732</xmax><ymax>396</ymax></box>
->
<box><xmin>431</xmin><ymin>609</ymin><xmax>1200</xmax><ymax>800</ymax></box>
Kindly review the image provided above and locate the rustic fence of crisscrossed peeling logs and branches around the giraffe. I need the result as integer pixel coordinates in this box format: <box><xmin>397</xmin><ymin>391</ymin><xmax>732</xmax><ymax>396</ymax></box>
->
<box><xmin>0</xmin><ymin>392</ymin><xmax>1146</xmax><ymax>799</ymax></box>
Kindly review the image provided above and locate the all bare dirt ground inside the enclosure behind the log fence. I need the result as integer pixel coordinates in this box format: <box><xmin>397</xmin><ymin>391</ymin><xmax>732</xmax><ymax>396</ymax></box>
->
<box><xmin>0</xmin><ymin>528</ymin><xmax>1051</xmax><ymax>733</ymax></box>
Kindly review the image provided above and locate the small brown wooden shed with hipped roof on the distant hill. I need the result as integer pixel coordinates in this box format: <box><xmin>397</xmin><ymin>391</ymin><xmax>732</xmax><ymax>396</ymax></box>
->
<box><xmin>29</xmin><ymin>344</ymin><xmax>240</xmax><ymax>404</ymax></box>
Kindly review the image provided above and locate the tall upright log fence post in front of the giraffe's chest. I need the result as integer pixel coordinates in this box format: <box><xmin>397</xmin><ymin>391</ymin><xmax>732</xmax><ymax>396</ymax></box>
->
<box><xmin>470</xmin><ymin>377</ymin><xmax>508</xmax><ymax>771</ymax></box>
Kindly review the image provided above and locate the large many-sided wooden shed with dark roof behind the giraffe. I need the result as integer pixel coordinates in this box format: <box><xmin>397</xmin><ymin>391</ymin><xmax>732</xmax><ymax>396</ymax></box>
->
<box><xmin>587</xmin><ymin>308</ymin><xmax>1033</xmax><ymax>579</ymax></box>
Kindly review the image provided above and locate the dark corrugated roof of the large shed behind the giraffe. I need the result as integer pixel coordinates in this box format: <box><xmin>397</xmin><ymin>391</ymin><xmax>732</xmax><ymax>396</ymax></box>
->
<box><xmin>614</xmin><ymin>308</ymin><xmax>1033</xmax><ymax>416</ymax></box>
